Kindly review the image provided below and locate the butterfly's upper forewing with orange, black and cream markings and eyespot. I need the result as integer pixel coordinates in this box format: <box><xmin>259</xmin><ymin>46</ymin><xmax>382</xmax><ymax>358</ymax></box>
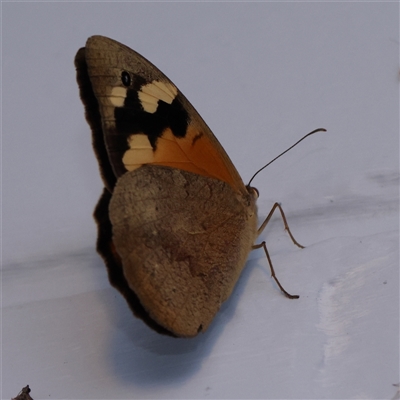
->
<box><xmin>85</xmin><ymin>36</ymin><xmax>245</xmax><ymax>193</ymax></box>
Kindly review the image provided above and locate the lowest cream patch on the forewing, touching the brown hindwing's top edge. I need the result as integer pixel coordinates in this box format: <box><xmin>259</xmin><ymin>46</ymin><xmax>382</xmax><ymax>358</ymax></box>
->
<box><xmin>122</xmin><ymin>134</ymin><xmax>154</xmax><ymax>171</ymax></box>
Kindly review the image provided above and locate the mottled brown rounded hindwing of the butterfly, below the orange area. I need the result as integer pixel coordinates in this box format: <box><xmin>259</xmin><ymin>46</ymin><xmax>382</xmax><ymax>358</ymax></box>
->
<box><xmin>110</xmin><ymin>165</ymin><xmax>257</xmax><ymax>337</ymax></box>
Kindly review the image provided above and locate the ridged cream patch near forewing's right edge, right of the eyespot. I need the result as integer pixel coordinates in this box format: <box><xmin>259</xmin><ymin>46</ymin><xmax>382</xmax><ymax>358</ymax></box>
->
<box><xmin>138</xmin><ymin>81</ymin><xmax>178</xmax><ymax>114</ymax></box>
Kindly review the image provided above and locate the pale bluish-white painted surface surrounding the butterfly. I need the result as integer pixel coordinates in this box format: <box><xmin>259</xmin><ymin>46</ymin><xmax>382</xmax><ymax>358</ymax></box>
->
<box><xmin>1</xmin><ymin>2</ymin><xmax>400</xmax><ymax>399</ymax></box>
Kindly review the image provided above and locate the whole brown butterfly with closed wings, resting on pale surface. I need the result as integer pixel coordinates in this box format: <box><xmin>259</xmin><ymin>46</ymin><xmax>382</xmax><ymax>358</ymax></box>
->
<box><xmin>75</xmin><ymin>36</ymin><xmax>318</xmax><ymax>337</ymax></box>
